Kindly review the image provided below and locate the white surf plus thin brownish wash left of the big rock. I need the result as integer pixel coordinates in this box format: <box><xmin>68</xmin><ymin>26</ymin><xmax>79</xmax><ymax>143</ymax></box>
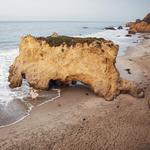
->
<box><xmin>0</xmin><ymin>49</ymin><xmax>60</xmax><ymax>128</ymax></box>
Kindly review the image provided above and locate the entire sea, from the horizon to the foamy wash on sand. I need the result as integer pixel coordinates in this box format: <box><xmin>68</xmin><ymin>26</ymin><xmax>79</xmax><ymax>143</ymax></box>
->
<box><xmin>0</xmin><ymin>21</ymin><xmax>137</xmax><ymax>126</ymax></box>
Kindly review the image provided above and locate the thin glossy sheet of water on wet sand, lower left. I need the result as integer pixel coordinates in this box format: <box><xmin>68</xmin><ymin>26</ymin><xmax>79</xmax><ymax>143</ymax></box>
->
<box><xmin>0</xmin><ymin>90</ymin><xmax>60</xmax><ymax>127</ymax></box>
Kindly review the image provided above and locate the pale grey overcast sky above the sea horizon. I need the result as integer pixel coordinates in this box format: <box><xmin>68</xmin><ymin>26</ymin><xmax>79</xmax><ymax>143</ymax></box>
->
<box><xmin>0</xmin><ymin>0</ymin><xmax>150</xmax><ymax>21</ymax></box>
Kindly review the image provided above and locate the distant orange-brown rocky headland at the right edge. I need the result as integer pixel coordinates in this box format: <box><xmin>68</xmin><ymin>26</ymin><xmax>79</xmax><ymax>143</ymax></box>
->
<box><xmin>126</xmin><ymin>13</ymin><xmax>150</xmax><ymax>34</ymax></box>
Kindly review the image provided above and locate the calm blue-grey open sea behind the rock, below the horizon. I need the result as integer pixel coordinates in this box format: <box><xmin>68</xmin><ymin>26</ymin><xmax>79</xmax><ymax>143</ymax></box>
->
<box><xmin>0</xmin><ymin>21</ymin><xmax>122</xmax><ymax>50</ymax></box>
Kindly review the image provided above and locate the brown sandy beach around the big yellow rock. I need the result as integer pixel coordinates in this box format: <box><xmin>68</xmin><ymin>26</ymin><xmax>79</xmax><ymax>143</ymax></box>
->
<box><xmin>0</xmin><ymin>34</ymin><xmax>150</xmax><ymax>150</ymax></box>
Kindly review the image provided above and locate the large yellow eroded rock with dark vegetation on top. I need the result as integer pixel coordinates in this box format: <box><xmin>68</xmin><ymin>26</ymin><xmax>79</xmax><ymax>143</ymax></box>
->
<box><xmin>9</xmin><ymin>36</ymin><xmax>143</xmax><ymax>100</ymax></box>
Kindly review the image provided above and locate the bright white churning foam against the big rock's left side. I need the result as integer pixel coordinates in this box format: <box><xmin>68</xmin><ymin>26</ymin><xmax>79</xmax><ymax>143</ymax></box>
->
<box><xmin>0</xmin><ymin>49</ymin><xmax>28</xmax><ymax>105</ymax></box>
